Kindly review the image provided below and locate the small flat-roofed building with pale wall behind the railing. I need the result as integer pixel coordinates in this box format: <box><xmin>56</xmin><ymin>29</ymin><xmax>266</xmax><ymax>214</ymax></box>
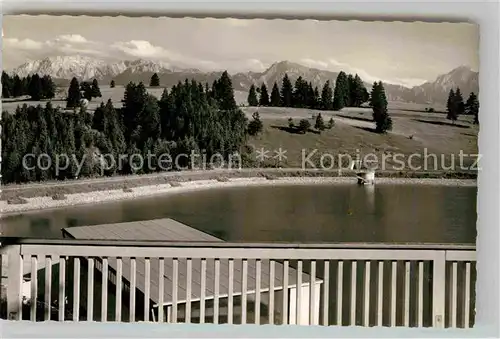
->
<box><xmin>57</xmin><ymin>219</ymin><xmax>322</xmax><ymax>324</ymax></box>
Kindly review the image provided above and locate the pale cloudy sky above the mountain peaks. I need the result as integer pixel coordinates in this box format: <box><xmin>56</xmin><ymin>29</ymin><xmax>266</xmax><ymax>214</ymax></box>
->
<box><xmin>2</xmin><ymin>15</ymin><xmax>479</xmax><ymax>86</ymax></box>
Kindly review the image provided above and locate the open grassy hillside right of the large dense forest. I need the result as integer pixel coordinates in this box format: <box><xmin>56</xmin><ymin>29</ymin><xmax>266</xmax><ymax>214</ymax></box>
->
<box><xmin>244</xmin><ymin>107</ymin><xmax>479</xmax><ymax>170</ymax></box>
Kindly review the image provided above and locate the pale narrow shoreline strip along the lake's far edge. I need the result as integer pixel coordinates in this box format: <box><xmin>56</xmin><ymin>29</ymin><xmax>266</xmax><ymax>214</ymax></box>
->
<box><xmin>0</xmin><ymin>176</ymin><xmax>477</xmax><ymax>217</ymax></box>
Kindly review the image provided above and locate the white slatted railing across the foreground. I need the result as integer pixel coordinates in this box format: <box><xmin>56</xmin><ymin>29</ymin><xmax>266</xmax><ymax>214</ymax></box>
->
<box><xmin>1</xmin><ymin>240</ymin><xmax>476</xmax><ymax>328</ymax></box>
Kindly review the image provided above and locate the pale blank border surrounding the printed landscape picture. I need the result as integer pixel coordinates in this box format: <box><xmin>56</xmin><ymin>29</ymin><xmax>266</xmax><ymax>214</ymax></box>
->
<box><xmin>0</xmin><ymin>0</ymin><xmax>500</xmax><ymax>338</ymax></box>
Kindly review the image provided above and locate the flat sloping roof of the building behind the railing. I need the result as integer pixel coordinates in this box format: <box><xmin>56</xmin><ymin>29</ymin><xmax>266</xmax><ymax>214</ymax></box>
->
<box><xmin>64</xmin><ymin>219</ymin><xmax>320</xmax><ymax>304</ymax></box>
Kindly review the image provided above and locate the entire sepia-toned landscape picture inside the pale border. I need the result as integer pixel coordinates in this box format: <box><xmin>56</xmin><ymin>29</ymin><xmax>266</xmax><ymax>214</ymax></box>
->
<box><xmin>0</xmin><ymin>15</ymin><xmax>481</xmax><ymax>328</ymax></box>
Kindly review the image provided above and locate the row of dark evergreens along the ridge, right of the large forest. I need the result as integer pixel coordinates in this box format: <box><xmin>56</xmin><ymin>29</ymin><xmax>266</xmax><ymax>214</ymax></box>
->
<box><xmin>247</xmin><ymin>72</ymin><xmax>369</xmax><ymax>110</ymax></box>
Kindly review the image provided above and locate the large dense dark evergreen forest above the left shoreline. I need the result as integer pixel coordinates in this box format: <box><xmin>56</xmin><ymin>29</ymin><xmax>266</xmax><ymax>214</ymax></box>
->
<box><xmin>2</xmin><ymin>72</ymin><xmax>248</xmax><ymax>183</ymax></box>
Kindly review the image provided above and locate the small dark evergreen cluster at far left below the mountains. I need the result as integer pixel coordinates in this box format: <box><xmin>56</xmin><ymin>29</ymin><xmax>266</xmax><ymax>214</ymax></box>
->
<box><xmin>2</xmin><ymin>71</ymin><xmax>56</xmax><ymax>101</ymax></box>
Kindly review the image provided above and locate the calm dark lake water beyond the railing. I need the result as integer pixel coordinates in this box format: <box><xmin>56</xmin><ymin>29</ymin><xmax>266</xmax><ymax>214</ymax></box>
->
<box><xmin>0</xmin><ymin>184</ymin><xmax>477</xmax><ymax>243</ymax></box>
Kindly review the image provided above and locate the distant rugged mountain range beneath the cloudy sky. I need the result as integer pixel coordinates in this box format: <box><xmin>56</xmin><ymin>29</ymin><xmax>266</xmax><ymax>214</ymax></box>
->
<box><xmin>9</xmin><ymin>56</ymin><xmax>479</xmax><ymax>104</ymax></box>
